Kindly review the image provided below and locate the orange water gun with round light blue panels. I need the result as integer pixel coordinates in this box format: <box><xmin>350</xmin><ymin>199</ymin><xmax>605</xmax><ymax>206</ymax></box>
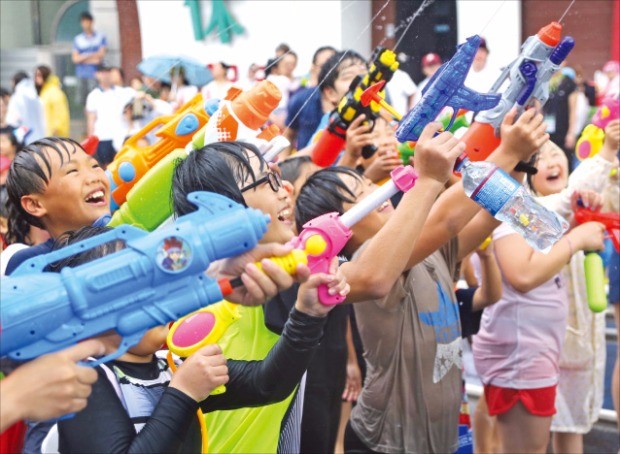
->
<box><xmin>106</xmin><ymin>93</ymin><xmax>209</xmax><ymax>211</ymax></box>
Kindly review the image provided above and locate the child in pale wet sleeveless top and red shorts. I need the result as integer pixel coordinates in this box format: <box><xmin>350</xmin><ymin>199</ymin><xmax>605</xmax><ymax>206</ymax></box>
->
<box><xmin>473</xmin><ymin>140</ymin><xmax>604</xmax><ymax>453</ymax></box>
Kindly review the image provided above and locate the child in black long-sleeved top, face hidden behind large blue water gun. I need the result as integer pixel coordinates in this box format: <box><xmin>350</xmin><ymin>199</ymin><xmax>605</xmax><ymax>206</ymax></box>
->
<box><xmin>29</xmin><ymin>227</ymin><xmax>348</xmax><ymax>452</ymax></box>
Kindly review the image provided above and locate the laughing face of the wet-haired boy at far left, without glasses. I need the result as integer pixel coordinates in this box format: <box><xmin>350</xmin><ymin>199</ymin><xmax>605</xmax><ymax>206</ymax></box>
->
<box><xmin>21</xmin><ymin>144</ymin><xmax>110</xmax><ymax>238</ymax></box>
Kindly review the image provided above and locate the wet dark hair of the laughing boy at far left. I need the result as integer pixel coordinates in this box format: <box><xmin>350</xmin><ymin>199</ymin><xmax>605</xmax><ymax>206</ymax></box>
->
<box><xmin>6</xmin><ymin>137</ymin><xmax>82</xmax><ymax>232</ymax></box>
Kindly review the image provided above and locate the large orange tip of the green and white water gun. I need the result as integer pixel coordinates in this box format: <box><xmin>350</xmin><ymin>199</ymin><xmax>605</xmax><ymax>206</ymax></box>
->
<box><xmin>231</xmin><ymin>80</ymin><xmax>282</xmax><ymax>129</ymax></box>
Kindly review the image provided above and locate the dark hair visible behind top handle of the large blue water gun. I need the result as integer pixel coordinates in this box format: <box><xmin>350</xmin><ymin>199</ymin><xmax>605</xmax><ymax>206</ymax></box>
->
<box><xmin>48</xmin><ymin>225</ymin><xmax>125</xmax><ymax>273</ymax></box>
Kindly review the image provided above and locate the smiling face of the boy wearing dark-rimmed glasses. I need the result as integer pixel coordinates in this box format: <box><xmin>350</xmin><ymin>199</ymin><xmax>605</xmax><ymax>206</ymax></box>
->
<box><xmin>239</xmin><ymin>156</ymin><xmax>295</xmax><ymax>247</ymax></box>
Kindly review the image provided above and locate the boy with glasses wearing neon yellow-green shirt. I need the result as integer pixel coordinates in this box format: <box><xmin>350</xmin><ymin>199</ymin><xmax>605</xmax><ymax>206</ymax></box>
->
<box><xmin>172</xmin><ymin>142</ymin><xmax>348</xmax><ymax>452</ymax></box>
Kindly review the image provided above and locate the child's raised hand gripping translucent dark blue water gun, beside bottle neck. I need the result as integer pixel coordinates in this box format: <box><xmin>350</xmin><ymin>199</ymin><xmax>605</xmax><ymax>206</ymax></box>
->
<box><xmin>413</xmin><ymin>122</ymin><xmax>465</xmax><ymax>185</ymax></box>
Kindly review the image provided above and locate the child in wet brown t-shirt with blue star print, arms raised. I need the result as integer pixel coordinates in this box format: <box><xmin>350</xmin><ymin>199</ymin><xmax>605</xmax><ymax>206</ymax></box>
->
<box><xmin>296</xmin><ymin>111</ymin><xmax>547</xmax><ymax>452</ymax></box>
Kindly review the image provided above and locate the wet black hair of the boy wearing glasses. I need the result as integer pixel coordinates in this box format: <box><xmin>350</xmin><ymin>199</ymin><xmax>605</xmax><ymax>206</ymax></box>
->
<box><xmin>172</xmin><ymin>142</ymin><xmax>267</xmax><ymax>216</ymax></box>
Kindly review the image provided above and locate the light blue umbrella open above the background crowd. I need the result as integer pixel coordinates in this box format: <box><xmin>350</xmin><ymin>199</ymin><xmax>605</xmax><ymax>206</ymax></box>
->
<box><xmin>138</xmin><ymin>56</ymin><xmax>213</xmax><ymax>87</ymax></box>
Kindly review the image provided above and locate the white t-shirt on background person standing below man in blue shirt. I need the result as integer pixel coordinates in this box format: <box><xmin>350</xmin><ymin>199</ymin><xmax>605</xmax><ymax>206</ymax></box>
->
<box><xmin>86</xmin><ymin>86</ymin><xmax>136</xmax><ymax>145</ymax></box>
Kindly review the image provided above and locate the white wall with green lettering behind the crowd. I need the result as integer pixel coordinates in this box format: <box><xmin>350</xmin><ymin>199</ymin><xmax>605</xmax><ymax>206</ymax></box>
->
<box><xmin>138</xmin><ymin>0</ymin><xmax>371</xmax><ymax>77</ymax></box>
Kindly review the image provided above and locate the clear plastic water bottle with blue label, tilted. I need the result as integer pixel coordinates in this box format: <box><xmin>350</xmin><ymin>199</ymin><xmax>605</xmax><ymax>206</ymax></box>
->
<box><xmin>456</xmin><ymin>158</ymin><xmax>568</xmax><ymax>253</ymax></box>
